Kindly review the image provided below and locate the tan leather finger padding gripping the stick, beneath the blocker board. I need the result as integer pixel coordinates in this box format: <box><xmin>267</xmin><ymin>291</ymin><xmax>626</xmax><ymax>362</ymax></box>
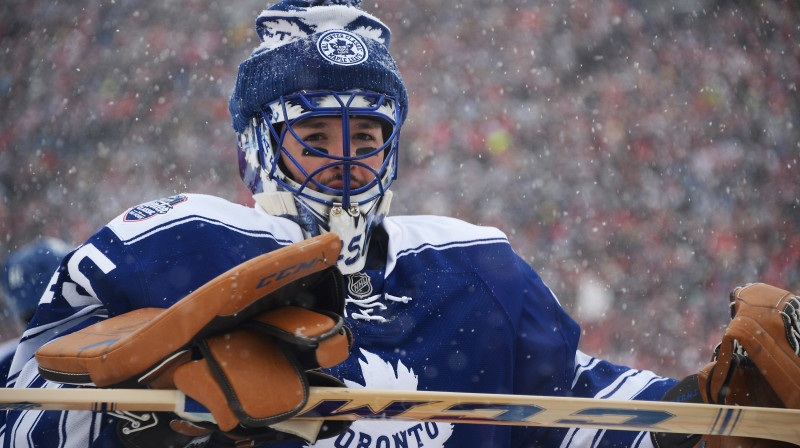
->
<box><xmin>173</xmin><ymin>306</ymin><xmax>352</xmax><ymax>431</ymax></box>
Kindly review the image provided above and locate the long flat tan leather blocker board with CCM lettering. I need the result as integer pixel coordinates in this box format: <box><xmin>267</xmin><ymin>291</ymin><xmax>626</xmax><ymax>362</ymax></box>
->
<box><xmin>36</xmin><ymin>234</ymin><xmax>345</xmax><ymax>387</ymax></box>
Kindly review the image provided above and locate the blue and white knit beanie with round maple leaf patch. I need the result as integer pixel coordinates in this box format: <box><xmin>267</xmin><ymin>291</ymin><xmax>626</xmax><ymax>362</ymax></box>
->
<box><xmin>228</xmin><ymin>0</ymin><xmax>408</xmax><ymax>133</ymax></box>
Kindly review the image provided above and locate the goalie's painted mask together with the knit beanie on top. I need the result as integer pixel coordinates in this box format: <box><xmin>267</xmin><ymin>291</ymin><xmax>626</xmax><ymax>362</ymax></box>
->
<box><xmin>229</xmin><ymin>0</ymin><xmax>408</xmax><ymax>274</ymax></box>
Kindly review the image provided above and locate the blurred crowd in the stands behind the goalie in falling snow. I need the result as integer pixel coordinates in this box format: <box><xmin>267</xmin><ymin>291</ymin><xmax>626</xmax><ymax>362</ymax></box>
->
<box><xmin>0</xmin><ymin>0</ymin><xmax>800</xmax><ymax>376</ymax></box>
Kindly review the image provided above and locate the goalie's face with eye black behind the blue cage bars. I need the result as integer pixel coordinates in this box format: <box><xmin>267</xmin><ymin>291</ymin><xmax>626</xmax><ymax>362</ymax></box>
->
<box><xmin>281</xmin><ymin>116</ymin><xmax>384</xmax><ymax>194</ymax></box>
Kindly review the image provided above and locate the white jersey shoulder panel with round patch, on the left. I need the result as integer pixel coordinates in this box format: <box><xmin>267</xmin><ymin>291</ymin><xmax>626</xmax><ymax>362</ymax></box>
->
<box><xmin>107</xmin><ymin>193</ymin><xmax>303</xmax><ymax>242</ymax></box>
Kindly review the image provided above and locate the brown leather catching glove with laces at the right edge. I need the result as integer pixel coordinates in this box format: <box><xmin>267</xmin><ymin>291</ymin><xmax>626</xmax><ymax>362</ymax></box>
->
<box><xmin>651</xmin><ymin>283</ymin><xmax>800</xmax><ymax>448</ymax></box>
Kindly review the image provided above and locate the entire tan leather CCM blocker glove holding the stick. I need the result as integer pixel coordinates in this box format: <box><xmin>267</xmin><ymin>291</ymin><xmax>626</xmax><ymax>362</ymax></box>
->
<box><xmin>36</xmin><ymin>234</ymin><xmax>352</xmax><ymax>447</ymax></box>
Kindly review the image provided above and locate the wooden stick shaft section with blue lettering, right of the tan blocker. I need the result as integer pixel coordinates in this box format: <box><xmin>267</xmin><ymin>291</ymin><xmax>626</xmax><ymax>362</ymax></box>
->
<box><xmin>299</xmin><ymin>388</ymin><xmax>800</xmax><ymax>443</ymax></box>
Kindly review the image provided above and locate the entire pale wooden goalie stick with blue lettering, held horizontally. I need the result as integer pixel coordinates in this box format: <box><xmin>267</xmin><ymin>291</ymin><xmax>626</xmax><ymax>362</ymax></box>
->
<box><xmin>0</xmin><ymin>387</ymin><xmax>800</xmax><ymax>443</ymax></box>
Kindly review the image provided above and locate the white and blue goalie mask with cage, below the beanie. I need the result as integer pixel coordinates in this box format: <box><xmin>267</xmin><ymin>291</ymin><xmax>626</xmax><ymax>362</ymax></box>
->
<box><xmin>238</xmin><ymin>90</ymin><xmax>402</xmax><ymax>274</ymax></box>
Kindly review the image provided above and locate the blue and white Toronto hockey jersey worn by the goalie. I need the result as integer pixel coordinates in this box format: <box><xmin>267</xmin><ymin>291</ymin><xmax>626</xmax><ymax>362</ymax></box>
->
<box><xmin>2</xmin><ymin>194</ymin><xmax>675</xmax><ymax>448</ymax></box>
